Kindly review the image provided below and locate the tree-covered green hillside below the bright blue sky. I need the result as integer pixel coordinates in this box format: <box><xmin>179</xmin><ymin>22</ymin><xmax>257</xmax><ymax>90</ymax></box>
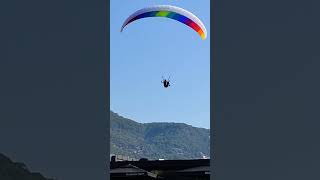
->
<box><xmin>110</xmin><ymin>111</ymin><xmax>210</xmax><ymax>160</ymax></box>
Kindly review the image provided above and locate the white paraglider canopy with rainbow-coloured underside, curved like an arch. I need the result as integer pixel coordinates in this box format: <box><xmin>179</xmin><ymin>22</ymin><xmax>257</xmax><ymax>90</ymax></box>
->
<box><xmin>121</xmin><ymin>5</ymin><xmax>207</xmax><ymax>39</ymax></box>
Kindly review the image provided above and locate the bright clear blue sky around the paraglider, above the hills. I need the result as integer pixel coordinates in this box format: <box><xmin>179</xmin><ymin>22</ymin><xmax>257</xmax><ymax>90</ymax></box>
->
<box><xmin>110</xmin><ymin>0</ymin><xmax>210</xmax><ymax>129</ymax></box>
